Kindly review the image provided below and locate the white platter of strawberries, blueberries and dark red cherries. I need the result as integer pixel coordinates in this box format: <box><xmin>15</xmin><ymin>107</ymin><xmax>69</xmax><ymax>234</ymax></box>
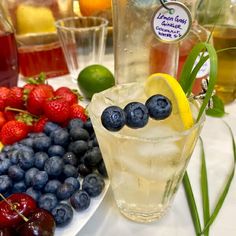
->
<box><xmin>0</xmin><ymin>76</ymin><xmax>109</xmax><ymax>235</ymax></box>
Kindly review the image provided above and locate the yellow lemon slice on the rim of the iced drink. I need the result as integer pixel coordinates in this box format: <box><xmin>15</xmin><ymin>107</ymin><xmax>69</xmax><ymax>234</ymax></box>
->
<box><xmin>144</xmin><ymin>73</ymin><xmax>194</xmax><ymax>131</ymax></box>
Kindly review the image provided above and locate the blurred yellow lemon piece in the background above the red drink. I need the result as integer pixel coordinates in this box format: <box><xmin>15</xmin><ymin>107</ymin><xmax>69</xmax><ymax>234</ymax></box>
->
<box><xmin>16</xmin><ymin>4</ymin><xmax>56</xmax><ymax>34</ymax></box>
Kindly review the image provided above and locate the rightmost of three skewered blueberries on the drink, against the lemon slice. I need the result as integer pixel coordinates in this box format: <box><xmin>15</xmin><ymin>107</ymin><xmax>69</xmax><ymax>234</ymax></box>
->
<box><xmin>145</xmin><ymin>94</ymin><xmax>172</xmax><ymax>120</ymax></box>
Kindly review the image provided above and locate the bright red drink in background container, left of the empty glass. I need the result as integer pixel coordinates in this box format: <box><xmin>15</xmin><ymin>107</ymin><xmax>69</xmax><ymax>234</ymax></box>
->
<box><xmin>18</xmin><ymin>36</ymin><xmax>68</xmax><ymax>78</ymax></box>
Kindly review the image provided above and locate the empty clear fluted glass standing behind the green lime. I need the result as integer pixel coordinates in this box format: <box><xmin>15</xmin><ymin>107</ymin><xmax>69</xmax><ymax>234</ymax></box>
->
<box><xmin>56</xmin><ymin>17</ymin><xmax>108</xmax><ymax>82</ymax></box>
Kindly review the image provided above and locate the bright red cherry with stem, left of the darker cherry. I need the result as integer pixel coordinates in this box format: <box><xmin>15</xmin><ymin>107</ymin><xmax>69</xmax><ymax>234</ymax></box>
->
<box><xmin>0</xmin><ymin>193</ymin><xmax>37</xmax><ymax>228</ymax></box>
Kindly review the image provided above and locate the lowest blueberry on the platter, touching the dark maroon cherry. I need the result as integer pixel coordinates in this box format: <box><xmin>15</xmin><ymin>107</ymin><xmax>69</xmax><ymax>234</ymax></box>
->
<box><xmin>51</xmin><ymin>203</ymin><xmax>73</xmax><ymax>226</ymax></box>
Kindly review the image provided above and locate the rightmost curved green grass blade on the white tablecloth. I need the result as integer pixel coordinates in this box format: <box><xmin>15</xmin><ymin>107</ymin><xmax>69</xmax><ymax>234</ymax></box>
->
<box><xmin>201</xmin><ymin>123</ymin><xmax>236</xmax><ymax>234</ymax></box>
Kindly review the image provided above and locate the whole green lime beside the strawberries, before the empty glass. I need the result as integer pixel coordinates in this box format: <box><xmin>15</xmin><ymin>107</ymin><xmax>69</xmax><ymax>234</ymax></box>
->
<box><xmin>77</xmin><ymin>65</ymin><xmax>115</xmax><ymax>99</ymax></box>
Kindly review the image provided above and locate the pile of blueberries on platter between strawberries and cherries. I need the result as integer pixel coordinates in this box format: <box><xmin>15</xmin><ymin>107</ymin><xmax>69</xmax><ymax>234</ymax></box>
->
<box><xmin>0</xmin><ymin>119</ymin><xmax>107</xmax><ymax>226</ymax></box>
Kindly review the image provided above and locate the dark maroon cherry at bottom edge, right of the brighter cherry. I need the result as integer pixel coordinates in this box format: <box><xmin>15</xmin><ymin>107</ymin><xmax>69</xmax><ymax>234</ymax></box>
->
<box><xmin>16</xmin><ymin>208</ymin><xmax>56</xmax><ymax>236</ymax></box>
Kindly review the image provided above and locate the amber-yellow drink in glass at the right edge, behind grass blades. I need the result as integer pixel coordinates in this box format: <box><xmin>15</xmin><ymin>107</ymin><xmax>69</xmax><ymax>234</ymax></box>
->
<box><xmin>206</xmin><ymin>25</ymin><xmax>236</xmax><ymax>103</ymax></box>
